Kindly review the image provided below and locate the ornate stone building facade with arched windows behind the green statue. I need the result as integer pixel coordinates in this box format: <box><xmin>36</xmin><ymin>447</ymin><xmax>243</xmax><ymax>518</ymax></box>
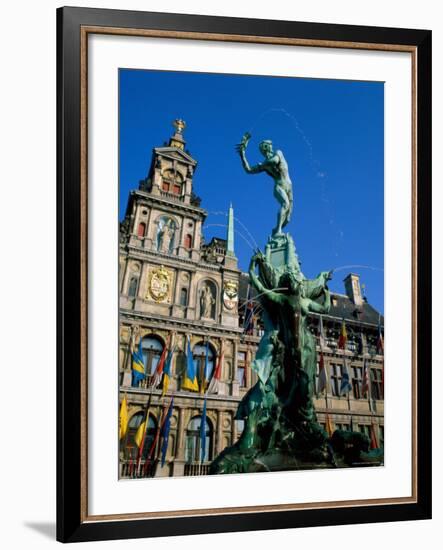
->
<box><xmin>119</xmin><ymin>120</ymin><xmax>383</xmax><ymax>478</ymax></box>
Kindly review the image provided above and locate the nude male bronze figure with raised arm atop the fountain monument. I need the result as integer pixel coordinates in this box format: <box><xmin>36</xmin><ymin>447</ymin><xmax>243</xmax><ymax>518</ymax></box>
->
<box><xmin>237</xmin><ymin>132</ymin><xmax>293</xmax><ymax>239</ymax></box>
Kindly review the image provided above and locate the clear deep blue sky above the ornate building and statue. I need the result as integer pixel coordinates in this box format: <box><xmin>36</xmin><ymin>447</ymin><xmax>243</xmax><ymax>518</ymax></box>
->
<box><xmin>119</xmin><ymin>69</ymin><xmax>384</xmax><ymax>312</ymax></box>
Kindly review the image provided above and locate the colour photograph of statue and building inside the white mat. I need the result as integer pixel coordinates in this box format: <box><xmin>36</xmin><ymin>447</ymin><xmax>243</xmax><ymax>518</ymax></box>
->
<box><xmin>118</xmin><ymin>67</ymin><xmax>389</xmax><ymax>483</ymax></box>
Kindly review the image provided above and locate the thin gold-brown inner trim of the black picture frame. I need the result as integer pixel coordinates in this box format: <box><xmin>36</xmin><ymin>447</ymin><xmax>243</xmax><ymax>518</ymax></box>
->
<box><xmin>58</xmin><ymin>8</ymin><xmax>434</xmax><ymax>540</ymax></box>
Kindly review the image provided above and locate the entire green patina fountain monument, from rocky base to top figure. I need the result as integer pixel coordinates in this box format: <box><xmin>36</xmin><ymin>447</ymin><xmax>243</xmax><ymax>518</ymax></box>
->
<box><xmin>209</xmin><ymin>134</ymin><xmax>380</xmax><ymax>474</ymax></box>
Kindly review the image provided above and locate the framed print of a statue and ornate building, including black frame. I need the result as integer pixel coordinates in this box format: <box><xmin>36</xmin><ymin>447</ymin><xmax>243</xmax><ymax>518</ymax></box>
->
<box><xmin>57</xmin><ymin>8</ymin><xmax>431</xmax><ymax>542</ymax></box>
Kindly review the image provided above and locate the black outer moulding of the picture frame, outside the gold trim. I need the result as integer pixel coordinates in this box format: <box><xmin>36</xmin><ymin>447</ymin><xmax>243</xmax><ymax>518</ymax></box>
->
<box><xmin>57</xmin><ymin>7</ymin><xmax>431</xmax><ymax>542</ymax></box>
